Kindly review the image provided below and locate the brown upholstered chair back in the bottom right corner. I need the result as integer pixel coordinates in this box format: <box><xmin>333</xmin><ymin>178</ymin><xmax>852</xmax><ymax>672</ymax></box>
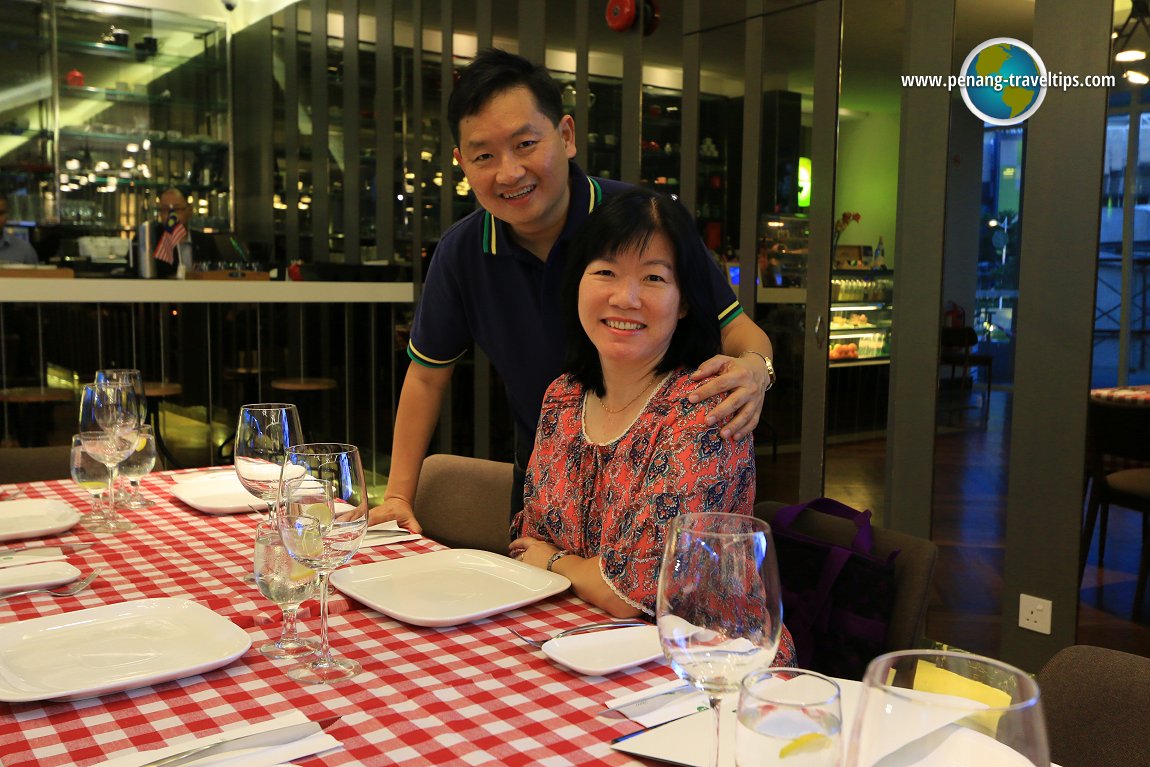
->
<box><xmin>1037</xmin><ymin>645</ymin><xmax>1150</xmax><ymax>767</ymax></box>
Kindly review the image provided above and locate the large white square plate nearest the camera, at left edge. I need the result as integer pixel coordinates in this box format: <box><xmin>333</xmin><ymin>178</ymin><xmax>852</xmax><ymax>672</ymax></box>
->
<box><xmin>0</xmin><ymin>599</ymin><xmax>252</xmax><ymax>703</ymax></box>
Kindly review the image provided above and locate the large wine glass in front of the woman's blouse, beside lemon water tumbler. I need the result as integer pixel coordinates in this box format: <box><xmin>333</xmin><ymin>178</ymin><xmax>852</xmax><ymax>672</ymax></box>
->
<box><xmin>656</xmin><ymin>512</ymin><xmax>783</xmax><ymax>765</ymax></box>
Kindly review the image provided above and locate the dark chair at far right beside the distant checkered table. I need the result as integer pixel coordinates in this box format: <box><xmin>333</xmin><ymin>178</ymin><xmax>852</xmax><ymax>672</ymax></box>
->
<box><xmin>1079</xmin><ymin>398</ymin><xmax>1150</xmax><ymax>619</ymax></box>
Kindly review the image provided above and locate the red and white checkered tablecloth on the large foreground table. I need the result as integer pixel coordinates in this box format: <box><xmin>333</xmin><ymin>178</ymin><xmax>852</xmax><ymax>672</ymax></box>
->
<box><xmin>0</xmin><ymin>473</ymin><xmax>674</xmax><ymax>767</ymax></box>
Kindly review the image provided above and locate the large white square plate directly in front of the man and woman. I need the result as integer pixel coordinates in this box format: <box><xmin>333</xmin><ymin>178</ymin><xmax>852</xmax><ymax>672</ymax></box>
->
<box><xmin>331</xmin><ymin>549</ymin><xmax>570</xmax><ymax>626</ymax></box>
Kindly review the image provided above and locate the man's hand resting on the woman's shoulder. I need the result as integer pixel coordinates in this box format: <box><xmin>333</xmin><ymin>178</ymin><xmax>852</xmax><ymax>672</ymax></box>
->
<box><xmin>689</xmin><ymin>354</ymin><xmax>767</xmax><ymax>440</ymax></box>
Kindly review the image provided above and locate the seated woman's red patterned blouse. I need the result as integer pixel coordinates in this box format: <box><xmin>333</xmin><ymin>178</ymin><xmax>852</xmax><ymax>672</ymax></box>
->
<box><xmin>512</xmin><ymin>369</ymin><xmax>795</xmax><ymax>666</ymax></box>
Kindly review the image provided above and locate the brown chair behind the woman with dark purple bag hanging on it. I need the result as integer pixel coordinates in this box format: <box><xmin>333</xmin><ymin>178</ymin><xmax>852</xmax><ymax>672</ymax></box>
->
<box><xmin>754</xmin><ymin>500</ymin><xmax>938</xmax><ymax>670</ymax></box>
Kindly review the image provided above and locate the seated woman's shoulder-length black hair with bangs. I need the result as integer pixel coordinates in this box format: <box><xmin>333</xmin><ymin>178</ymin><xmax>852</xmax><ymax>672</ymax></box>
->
<box><xmin>560</xmin><ymin>189</ymin><xmax>721</xmax><ymax>397</ymax></box>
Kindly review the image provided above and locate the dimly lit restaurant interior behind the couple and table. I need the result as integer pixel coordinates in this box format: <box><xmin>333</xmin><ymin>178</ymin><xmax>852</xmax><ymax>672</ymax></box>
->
<box><xmin>0</xmin><ymin>0</ymin><xmax>1150</xmax><ymax>764</ymax></box>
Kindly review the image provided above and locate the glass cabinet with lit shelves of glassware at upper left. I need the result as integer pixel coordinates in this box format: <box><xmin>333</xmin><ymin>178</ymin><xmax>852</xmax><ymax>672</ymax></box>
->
<box><xmin>0</xmin><ymin>0</ymin><xmax>231</xmax><ymax>240</ymax></box>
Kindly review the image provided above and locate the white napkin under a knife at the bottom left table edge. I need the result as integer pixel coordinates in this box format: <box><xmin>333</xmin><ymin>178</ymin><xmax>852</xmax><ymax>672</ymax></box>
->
<box><xmin>101</xmin><ymin>711</ymin><xmax>343</xmax><ymax>767</ymax></box>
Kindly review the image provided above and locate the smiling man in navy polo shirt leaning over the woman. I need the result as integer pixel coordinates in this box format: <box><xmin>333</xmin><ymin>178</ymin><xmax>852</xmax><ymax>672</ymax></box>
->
<box><xmin>371</xmin><ymin>49</ymin><xmax>774</xmax><ymax>532</ymax></box>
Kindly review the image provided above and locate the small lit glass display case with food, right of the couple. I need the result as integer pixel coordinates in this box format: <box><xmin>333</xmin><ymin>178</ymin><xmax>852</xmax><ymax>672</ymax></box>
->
<box><xmin>827</xmin><ymin>269</ymin><xmax>895</xmax><ymax>366</ymax></box>
